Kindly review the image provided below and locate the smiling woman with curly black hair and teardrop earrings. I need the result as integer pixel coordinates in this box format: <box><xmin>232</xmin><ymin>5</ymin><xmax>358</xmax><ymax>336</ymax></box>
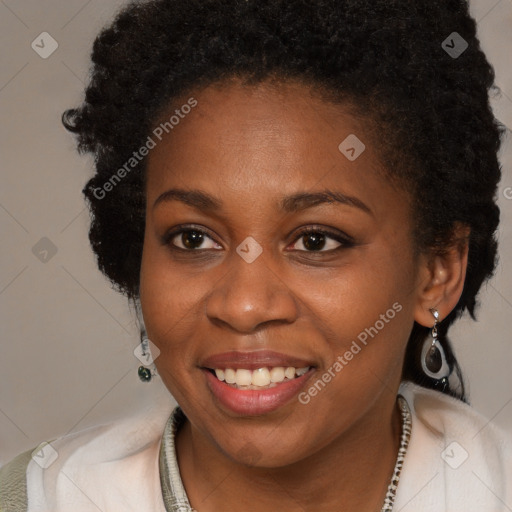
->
<box><xmin>0</xmin><ymin>0</ymin><xmax>512</xmax><ymax>512</ymax></box>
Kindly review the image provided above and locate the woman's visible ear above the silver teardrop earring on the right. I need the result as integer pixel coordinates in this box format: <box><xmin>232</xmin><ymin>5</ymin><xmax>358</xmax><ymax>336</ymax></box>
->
<box><xmin>414</xmin><ymin>224</ymin><xmax>470</xmax><ymax>327</ymax></box>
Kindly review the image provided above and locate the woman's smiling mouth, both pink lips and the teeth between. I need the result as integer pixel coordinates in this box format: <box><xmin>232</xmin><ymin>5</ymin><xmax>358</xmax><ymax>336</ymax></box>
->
<box><xmin>201</xmin><ymin>350</ymin><xmax>314</xmax><ymax>415</ymax></box>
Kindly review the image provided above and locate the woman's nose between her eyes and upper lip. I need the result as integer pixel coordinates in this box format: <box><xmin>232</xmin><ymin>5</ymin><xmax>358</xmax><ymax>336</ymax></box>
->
<box><xmin>206</xmin><ymin>249</ymin><xmax>298</xmax><ymax>334</ymax></box>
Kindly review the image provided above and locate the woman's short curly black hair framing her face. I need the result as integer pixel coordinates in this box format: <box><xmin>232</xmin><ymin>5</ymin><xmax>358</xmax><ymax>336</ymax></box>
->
<box><xmin>63</xmin><ymin>0</ymin><xmax>504</xmax><ymax>401</ymax></box>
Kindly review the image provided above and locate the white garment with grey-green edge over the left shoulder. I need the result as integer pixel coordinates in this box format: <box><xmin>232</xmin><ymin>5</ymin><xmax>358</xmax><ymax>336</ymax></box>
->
<box><xmin>0</xmin><ymin>402</ymin><xmax>173</xmax><ymax>512</ymax></box>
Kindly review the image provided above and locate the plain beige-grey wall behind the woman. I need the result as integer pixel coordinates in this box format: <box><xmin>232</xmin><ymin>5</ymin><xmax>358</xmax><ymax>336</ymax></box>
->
<box><xmin>0</xmin><ymin>0</ymin><xmax>512</xmax><ymax>465</ymax></box>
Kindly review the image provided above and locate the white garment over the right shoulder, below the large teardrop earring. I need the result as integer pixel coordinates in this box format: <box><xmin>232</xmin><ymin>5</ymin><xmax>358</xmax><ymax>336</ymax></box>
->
<box><xmin>397</xmin><ymin>382</ymin><xmax>512</xmax><ymax>512</ymax></box>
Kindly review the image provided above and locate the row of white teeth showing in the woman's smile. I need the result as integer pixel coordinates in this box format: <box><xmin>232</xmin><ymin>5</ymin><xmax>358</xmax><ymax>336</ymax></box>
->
<box><xmin>210</xmin><ymin>366</ymin><xmax>310</xmax><ymax>389</ymax></box>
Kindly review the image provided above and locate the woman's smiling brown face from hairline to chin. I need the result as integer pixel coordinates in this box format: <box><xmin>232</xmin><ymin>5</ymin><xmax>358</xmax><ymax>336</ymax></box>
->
<box><xmin>140</xmin><ymin>83</ymin><xmax>420</xmax><ymax>467</ymax></box>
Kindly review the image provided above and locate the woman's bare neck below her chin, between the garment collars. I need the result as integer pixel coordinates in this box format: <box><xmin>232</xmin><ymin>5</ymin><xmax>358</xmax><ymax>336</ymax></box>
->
<box><xmin>176</xmin><ymin>397</ymin><xmax>401</xmax><ymax>512</ymax></box>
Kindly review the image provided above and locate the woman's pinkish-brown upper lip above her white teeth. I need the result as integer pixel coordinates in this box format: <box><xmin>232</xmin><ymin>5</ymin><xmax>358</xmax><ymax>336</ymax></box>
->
<box><xmin>200</xmin><ymin>350</ymin><xmax>314</xmax><ymax>370</ymax></box>
